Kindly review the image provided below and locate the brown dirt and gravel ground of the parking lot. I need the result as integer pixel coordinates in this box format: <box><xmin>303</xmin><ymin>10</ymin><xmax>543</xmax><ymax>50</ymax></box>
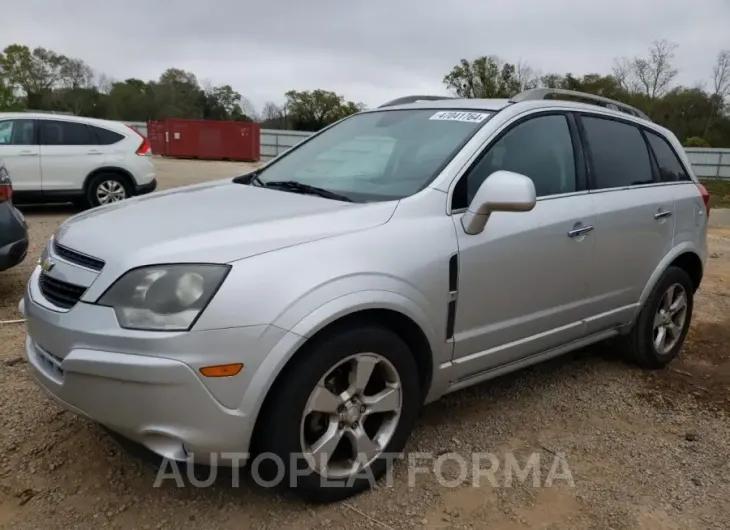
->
<box><xmin>0</xmin><ymin>160</ymin><xmax>730</xmax><ymax>530</ymax></box>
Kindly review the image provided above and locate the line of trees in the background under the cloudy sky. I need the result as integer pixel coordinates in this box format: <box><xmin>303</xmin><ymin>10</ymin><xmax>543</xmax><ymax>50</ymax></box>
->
<box><xmin>0</xmin><ymin>40</ymin><xmax>730</xmax><ymax>147</ymax></box>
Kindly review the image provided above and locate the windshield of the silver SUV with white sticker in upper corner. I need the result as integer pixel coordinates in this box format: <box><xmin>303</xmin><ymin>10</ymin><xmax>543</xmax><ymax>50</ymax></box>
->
<box><xmin>258</xmin><ymin>109</ymin><xmax>493</xmax><ymax>202</ymax></box>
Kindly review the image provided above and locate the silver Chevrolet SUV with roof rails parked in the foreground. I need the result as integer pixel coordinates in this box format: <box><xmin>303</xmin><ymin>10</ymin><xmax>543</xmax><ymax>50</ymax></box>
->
<box><xmin>21</xmin><ymin>89</ymin><xmax>709</xmax><ymax>500</ymax></box>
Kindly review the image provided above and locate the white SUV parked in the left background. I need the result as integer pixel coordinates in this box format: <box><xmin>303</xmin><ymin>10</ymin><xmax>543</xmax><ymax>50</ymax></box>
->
<box><xmin>0</xmin><ymin>112</ymin><xmax>157</xmax><ymax>207</ymax></box>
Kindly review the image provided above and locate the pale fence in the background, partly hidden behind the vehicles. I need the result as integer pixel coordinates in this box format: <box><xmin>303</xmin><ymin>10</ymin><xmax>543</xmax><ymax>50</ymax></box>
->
<box><xmin>124</xmin><ymin>122</ymin><xmax>730</xmax><ymax>179</ymax></box>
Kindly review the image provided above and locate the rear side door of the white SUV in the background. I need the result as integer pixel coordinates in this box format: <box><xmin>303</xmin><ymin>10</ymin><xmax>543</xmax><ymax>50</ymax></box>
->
<box><xmin>39</xmin><ymin>119</ymin><xmax>105</xmax><ymax>192</ymax></box>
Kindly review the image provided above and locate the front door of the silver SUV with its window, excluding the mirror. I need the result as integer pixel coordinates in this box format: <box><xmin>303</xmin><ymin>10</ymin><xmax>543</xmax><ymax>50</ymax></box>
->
<box><xmin>452</xmin><ymin>113</ymin><xmax>595</xmax><ymax>380</ymax></box>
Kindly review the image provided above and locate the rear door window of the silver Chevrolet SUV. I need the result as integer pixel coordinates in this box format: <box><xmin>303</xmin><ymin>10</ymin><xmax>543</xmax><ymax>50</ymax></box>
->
<box><xmin>582</xmin><ymin>116</ymin><xmax>654</xmax><ymax>190</ymax></box>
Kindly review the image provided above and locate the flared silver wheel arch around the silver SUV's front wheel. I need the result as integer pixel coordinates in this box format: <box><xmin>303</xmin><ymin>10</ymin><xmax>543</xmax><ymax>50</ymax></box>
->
<box><xmin>239</xmin><ymin>290</ymin><xmax>440</xmax><ymax>450</ymax></box>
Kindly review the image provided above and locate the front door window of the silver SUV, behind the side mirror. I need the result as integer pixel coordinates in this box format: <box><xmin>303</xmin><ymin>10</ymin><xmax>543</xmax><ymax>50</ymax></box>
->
<box><xmin>454</xmin><ymin>115</ymin><xmax>576</xmax><ymax>208</ymax></box>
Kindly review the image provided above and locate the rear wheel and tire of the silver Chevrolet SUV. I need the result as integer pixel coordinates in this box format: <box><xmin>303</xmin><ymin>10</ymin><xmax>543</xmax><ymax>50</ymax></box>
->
<box><xmin>622</xmin><ymin>267</ymin><xmax>694</xmax><ymax>370</ymax></box>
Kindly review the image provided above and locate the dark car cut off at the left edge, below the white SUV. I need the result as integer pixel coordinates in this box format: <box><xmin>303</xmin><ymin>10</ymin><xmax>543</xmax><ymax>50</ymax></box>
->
<box><xmin>0</xmin><ymin>160</ymin><xmax>28</xmax><ymax>272</ymax></box>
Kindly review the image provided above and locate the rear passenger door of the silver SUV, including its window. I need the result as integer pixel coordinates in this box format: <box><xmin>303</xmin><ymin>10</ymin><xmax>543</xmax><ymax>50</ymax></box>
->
<box><xmin>579</xmin><ymin>113</ymin><xmax>674</xmax><ymax>333</ymax></box>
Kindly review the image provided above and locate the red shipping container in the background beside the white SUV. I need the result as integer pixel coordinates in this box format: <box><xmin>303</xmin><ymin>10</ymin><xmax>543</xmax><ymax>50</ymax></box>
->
<box><xmin>161</xmin><ymin>118</ymin><xmax>261</xmax><ymax>162</ymax></box>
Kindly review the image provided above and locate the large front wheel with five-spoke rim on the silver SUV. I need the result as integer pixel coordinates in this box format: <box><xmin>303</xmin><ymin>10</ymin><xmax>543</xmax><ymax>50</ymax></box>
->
<box><xmin>251</xmin><ymin>325</ymin><xmax>422</xmax><ymax>502</ymax></box>
